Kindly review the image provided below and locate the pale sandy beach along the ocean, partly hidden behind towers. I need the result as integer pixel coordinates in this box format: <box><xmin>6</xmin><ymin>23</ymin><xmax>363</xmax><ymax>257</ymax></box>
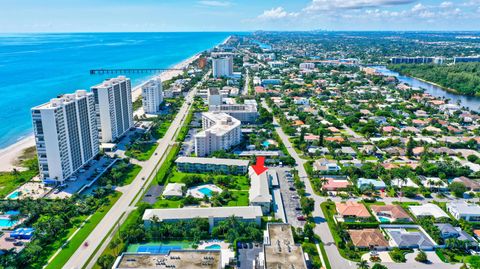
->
<box><xmin>0</xmin><ymin>54</ymin><xmax>200</xmax><ymax>172</ymax></box>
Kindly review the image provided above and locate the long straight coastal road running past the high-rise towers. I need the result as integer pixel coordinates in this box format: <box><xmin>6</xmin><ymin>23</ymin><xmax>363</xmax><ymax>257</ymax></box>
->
<box><xmin>63</xmin><ymin>76</ymin><xmax>202</xmax><ymax>269</ymax></box>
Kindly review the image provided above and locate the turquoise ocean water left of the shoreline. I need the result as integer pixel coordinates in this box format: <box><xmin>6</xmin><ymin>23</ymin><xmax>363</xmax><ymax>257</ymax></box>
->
<box><xmin>0</xmin><ymin>33</ymin><xmax>230</xmax><ymax>148</ymax></box>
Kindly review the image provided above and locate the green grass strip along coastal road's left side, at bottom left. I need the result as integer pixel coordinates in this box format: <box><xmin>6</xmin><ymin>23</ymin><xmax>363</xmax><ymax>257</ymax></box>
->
<box><xmin>45</xmin><ymin>192</ymin><xmax>121</xmax><ymax>269</ymax></box>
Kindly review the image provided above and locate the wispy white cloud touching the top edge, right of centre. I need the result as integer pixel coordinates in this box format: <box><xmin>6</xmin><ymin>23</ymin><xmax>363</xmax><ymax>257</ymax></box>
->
<box><xmin>305</xmin><ymin>0</ymin><xmax>415</xmax><ymax>12</ymax></box>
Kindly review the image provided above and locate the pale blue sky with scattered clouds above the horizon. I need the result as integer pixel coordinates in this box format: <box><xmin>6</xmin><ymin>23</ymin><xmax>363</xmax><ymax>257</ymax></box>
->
<box><xmin>0</xmin><ymin>0</ymin><xmax>480</xmax><ymax>32</ymax></box>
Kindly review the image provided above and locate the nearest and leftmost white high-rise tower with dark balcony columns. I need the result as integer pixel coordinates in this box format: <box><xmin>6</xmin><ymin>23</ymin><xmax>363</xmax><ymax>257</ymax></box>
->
<box><xmin>31</xmin><ymin>90</ymin><xmax>99</xmax><ymax>183</ymax></box>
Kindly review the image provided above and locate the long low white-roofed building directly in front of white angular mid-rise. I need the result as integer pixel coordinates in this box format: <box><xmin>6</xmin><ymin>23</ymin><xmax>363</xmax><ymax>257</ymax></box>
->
<box><xmin>175</xmin><ymin>156</ymin><xmax>249</xmax><ymax>175</ymax></box>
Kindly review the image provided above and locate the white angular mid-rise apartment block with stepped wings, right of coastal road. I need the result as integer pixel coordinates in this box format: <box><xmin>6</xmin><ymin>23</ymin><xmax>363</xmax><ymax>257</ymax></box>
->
<box><xmin>195</xmin><ymin>112</ymin><xmax>242</xmax><ymax>157</ymax></box>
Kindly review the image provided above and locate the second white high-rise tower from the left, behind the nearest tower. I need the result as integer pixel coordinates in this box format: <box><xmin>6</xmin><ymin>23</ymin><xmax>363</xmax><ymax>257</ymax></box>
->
<box><xmin>92</xmin><ymin>76</ymin><xmax>134</xmax><ymax>143</ymax></box>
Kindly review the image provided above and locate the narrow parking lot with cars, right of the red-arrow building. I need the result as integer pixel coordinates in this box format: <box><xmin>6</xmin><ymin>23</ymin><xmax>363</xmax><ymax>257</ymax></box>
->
<box><xmin>276</xmin><ymin>168</ymin><xmax>305</xmax><ymax>227</ymax></box>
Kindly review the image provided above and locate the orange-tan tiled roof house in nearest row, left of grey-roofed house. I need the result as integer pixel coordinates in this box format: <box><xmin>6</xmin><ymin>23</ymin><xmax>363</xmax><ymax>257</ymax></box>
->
<box><xmin>348</xmin><ymin>229</ymin><xmax>388</xmax><ymax>250</ymax></box>
